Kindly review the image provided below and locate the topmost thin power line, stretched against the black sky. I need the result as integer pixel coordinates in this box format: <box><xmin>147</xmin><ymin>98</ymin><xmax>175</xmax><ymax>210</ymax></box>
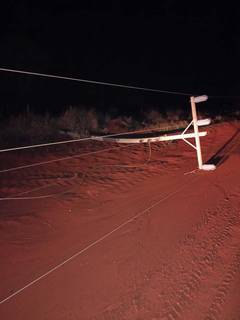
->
<box><xmin>0</xmin><ymin>68</ymin><xmax>193</xmax><ymax>97</ymax></box>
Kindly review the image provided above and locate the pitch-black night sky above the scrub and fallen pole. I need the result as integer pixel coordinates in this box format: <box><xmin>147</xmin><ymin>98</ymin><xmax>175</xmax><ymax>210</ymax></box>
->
<box><xmin>0</xmin><ymin>0</ymin><xmax>240</xmax><ymax>114</ymax></box>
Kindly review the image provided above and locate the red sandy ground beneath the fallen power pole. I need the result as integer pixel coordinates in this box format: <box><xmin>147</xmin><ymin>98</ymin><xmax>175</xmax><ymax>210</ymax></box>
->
<box><xmin>0</xmin><ymin>123</ymin><xmax>240</xmax><ymax>320</ymax></box>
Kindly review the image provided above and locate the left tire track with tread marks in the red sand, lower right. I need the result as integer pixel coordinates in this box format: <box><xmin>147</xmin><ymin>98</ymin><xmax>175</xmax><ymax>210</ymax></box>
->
<box><xmin>96</xmin><ymin>192</ymin><xmax>240</xmax><ymax>320</ymax></box>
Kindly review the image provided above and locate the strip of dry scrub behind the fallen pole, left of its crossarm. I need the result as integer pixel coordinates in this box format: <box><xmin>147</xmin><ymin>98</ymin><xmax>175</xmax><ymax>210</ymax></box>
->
<box><xmin>0</xmin><ymin>106</ymin><xmax>197</xmax><ymax>145</ymax></box>
